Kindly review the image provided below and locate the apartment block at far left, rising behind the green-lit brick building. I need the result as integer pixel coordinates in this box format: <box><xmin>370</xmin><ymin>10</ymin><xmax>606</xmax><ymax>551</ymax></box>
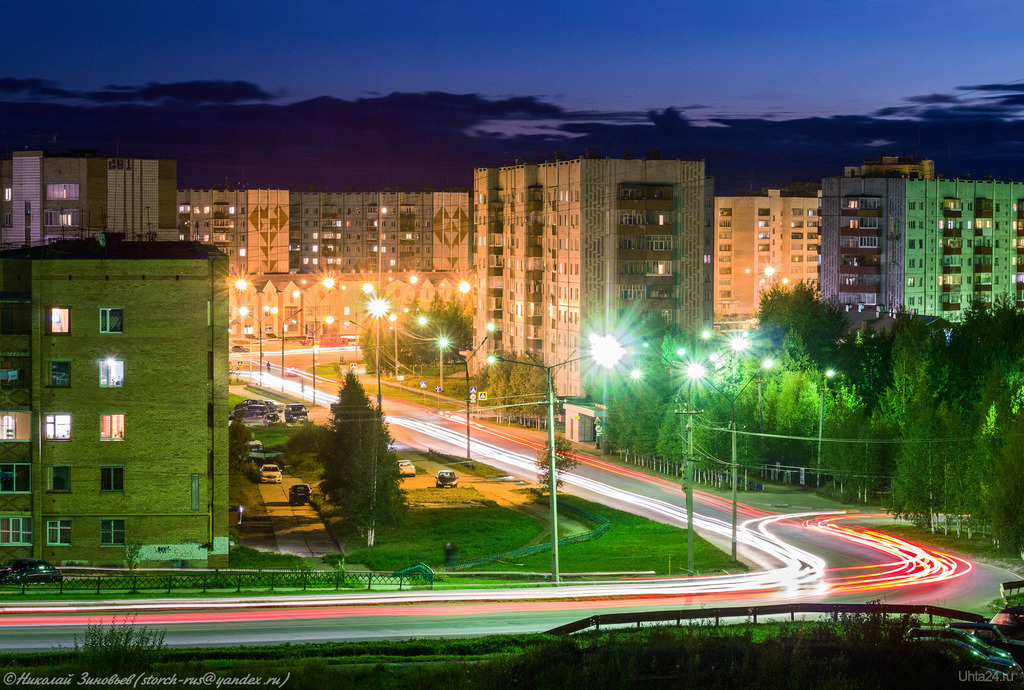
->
<box><xmin>0</xmin><ymin>150</ymin><xmax>178</xmax><ymax>249</ymax></box>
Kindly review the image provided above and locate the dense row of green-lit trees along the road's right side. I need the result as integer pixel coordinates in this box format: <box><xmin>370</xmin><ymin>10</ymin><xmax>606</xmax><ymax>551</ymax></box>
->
<box><xmin>593</xmin><ymin>284</ymin><xmax>1024</xmax><ymax>551</ymax></box>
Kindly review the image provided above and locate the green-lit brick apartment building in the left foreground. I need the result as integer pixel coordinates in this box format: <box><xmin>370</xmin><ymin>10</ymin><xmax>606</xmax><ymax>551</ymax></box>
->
<box><xmin>0</xmin><ymin>234</ymin><xmax>228</xmax><ymax>566</ymax></box>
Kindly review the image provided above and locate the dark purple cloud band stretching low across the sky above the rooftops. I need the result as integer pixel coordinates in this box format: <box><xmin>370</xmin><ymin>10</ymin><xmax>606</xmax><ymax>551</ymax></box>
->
<box><xmin>6</xmin><ymin>85</ymin><xmax>1024</xmax><ymax>193</ymax></box>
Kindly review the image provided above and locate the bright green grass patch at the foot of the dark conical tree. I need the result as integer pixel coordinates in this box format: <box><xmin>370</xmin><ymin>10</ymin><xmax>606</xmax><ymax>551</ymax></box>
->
<box><xmin>339</xmin><ymin>505</ymin><xmax>544</xmax><ymax>570</ymax></box>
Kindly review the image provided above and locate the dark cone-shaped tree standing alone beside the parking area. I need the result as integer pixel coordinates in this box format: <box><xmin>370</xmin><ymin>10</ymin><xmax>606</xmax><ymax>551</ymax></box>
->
<box><xmin>315</xmin><ymin>372</ymin><xmax>406</xmax><ymax>547</ymax></box>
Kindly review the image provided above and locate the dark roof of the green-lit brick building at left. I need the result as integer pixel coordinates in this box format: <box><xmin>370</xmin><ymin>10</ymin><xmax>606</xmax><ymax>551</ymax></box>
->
<box><xmin>0</xmin><ymin>233</ymin><xmax>227</xmax><ymax>261</ymax></box>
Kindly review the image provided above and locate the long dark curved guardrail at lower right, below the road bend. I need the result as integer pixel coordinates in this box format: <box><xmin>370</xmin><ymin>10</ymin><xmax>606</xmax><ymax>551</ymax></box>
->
<box><xmin>547</xmin><ymin>603</ymin><xmax>986</xmax><ymax>635</ymax></box>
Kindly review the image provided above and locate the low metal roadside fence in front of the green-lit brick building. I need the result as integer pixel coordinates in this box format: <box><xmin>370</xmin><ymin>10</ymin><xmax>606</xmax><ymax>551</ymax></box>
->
<box><xmin>0</xmin><ymin>566</ymin><xmax>434</xmax><ymax>594</ymax></box>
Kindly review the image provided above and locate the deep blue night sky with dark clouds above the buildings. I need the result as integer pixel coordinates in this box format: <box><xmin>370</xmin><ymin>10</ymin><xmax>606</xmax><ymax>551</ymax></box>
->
<box><xmin>6</xmin><ymin>0</ymin><xmax>1024</xmax><ymax>193</ymax></box>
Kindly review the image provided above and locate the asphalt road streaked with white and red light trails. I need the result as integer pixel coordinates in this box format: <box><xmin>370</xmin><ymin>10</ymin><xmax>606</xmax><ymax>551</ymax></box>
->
<box><xmin>0</xmin><ymin>352</ymin><xmax>1017</xmax><ymax>650</ymax></box>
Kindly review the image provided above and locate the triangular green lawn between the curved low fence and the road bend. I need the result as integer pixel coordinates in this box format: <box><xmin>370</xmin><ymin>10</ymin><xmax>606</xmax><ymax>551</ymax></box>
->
<box><xmin>464</xmin><ymin>497</ymin><xmax>746</xmax><ymax>575</ymax></box>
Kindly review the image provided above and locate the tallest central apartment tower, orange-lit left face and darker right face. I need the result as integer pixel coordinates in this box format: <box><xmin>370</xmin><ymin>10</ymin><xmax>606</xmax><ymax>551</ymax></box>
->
<box><xmin>473</xmin><ymin>157</ymin><xmax>714</xmax><ymax>395</ymax></box>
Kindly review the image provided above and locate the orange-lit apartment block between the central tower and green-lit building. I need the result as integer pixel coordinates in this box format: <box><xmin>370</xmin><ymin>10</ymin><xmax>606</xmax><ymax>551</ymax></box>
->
<box><xmin>715</xmin><ymin>187</ymin><xmax>821</xmax><ymax>328</ymax></box>
